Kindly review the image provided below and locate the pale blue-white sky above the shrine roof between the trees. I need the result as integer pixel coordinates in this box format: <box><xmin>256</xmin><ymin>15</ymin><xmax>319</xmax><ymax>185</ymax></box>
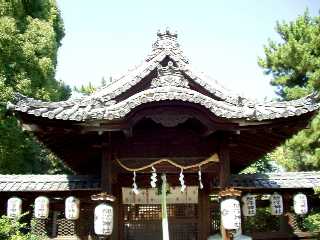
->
<box><xmin>56</xmin><ymin>0</ymin><xmax>320</xmax><ymax>100</ymax></box>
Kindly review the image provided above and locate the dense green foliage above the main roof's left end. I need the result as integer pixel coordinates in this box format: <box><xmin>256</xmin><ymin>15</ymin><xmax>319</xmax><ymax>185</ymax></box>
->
<box><xmin>0</xmin><ymin>0</ymin><xmax>70</xmax><ymax>100</ymax></box>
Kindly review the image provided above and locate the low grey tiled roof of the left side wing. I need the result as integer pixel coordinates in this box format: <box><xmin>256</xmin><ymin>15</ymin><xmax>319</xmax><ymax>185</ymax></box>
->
<box><xmin>0</xmin><ymin>175</ymin><xmax>100</xmax><ymax>192</ymax></box>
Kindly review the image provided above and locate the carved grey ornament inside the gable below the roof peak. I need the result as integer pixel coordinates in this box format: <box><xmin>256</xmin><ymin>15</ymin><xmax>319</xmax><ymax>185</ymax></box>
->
<box><xmin>151</xmin><ymin>61</ymin><xmax>189</xmax><ymax>88</ymax></box>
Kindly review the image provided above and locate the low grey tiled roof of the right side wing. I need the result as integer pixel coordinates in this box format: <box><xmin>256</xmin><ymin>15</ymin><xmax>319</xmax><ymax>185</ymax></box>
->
<box><xmin>231</xmin><ymin>172</ymin><xmax>320</xmax><ymax>189</ymax></box>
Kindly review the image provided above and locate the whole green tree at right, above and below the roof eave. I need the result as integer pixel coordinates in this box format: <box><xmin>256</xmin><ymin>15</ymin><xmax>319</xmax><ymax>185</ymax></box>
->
<box><xmin>259</xmin><ymin>10</ymin><xmax>320</xmax><ymax>171</ymax></box>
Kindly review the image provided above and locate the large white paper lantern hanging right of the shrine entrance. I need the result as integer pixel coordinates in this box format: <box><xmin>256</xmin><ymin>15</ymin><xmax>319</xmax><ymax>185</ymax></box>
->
<box><xmin>220</xmin><ymin>199</ymin><xmax>241</xmax><ymax>230</ymax></box>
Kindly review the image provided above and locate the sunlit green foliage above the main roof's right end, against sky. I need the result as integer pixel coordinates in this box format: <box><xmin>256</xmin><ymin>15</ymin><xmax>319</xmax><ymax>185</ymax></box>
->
<box><xmin>258</xmin><ymin>11</ymin><xmax>320</xmax><ymax>100</ymax></box>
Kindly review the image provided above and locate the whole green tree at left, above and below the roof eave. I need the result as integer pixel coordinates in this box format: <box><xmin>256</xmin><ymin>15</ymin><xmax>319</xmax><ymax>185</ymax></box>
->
<box><xmin>0</xmin><ymin>0</ymin><xmax>71</xmax><ymax>173</ymax></box>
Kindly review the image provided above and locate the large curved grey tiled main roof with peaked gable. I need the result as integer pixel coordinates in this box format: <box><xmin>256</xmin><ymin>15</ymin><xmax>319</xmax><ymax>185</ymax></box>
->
<box><xmin>8</xmin><ymin>31</ymin><xmax>319</xmax><ymax>121</ymax></box>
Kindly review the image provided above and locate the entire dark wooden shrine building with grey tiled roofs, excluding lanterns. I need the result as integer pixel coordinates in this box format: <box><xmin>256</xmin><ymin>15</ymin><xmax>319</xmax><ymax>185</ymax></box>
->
<box><xmin>0</xmin><ymin>30</ymin><xmax>320</xmax><ymax>240</ymax></box>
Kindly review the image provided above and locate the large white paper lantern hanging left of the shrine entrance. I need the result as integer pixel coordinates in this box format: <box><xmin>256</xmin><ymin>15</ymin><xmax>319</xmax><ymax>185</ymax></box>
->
<box><xmin>94</xmin><ymin>203</ymin><xmax>113</xmax><ymax>236</ymax></box>
